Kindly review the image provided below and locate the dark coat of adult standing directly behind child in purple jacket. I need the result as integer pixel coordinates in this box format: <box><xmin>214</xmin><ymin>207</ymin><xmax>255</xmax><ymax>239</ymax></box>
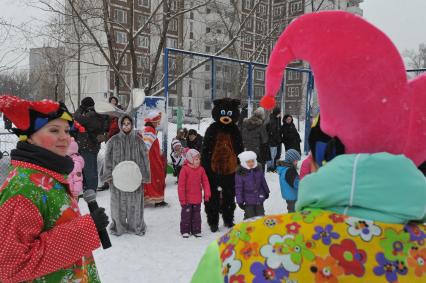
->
<box><xmin>241</xmin><ymin>115</ymin><xmax>268</xmax><ymax>159</ymax></box>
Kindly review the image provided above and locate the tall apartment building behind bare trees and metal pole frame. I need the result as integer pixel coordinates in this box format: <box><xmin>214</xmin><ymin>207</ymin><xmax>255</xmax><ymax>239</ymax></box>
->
<box><xmin>64</xmin><ymin>0</ymin><xmax>362</xmax><ymax>118</ymax></box>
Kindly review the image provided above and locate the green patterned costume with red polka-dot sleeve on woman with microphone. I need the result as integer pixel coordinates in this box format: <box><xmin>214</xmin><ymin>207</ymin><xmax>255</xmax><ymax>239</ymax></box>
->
<box><xmin>0</xmin><ymin>161</ymin><xmax>100</xmax><ymax>282</ymax></box>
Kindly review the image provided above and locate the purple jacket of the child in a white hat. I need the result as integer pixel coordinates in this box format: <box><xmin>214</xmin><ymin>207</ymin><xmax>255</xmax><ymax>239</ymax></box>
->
<box><xmin>235</xmin><ymin>164</ymin><xmax>269</xmax><ymax>205</ymax></box>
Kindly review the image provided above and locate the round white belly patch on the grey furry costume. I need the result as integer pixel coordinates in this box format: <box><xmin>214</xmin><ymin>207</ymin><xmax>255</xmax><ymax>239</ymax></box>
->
<box><xmin>112</xmin><ymin>161</ymin><xmax>142</xmax><ymax>193</ymax></box>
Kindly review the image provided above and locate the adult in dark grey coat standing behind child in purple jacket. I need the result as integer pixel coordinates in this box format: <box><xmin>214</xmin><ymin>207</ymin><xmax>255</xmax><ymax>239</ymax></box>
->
<box><xmin>241</xmin><ymin>107</ymin><xmax>270</xmax><ymax>168</ymax></box>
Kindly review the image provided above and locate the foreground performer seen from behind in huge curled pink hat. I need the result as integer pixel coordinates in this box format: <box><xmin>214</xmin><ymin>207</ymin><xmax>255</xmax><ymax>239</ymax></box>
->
<box><xmin>192</xmin><ymin>12</ymin><xmax>426</xmax><ymax>283</ymax></box>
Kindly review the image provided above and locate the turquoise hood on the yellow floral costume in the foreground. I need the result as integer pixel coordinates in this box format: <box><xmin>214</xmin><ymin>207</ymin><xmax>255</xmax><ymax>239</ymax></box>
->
<box><xmin>296</xmin><ymin>153</ymin><xmax>426</xmax><ymax>224</ymax></box>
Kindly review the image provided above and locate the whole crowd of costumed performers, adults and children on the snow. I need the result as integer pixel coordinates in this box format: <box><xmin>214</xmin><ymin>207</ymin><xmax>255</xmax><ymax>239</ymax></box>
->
<box><xmin>0</xmin><ymin>9</ymin><xmax>426</xmax><ymax>283</ymax></box>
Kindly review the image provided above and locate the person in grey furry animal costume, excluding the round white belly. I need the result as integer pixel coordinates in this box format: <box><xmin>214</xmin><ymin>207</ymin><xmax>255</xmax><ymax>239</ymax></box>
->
<box><xmin>103</xmin><ymin>115</ymin><xmax>151</xmax><ymax>236</ymax></box>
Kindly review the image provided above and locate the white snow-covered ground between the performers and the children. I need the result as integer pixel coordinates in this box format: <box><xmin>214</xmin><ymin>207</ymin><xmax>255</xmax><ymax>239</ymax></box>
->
<box><xmin>79</xmin><ymin>173</ymin><xmax>286</xmax><ymax>283</ymax></box>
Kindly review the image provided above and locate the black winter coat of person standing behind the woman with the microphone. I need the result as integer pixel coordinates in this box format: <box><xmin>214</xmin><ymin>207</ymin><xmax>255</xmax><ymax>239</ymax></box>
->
<box><xmin>74</xmin><ymin>106</ymin><xmax>108</xmax><ymax>154</ymax></box>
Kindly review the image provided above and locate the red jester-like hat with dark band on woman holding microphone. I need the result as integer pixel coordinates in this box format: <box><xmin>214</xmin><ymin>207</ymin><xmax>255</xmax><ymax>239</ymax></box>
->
<box><xmin>0</xmin><ymin>95</ymin><xmax>74</xmax><ymax>141</ymax></box>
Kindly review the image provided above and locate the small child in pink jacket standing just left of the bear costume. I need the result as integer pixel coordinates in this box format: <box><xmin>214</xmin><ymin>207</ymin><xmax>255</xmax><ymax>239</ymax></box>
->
<box><xmin>178</xmin><ymin>149</ymin><xmax>210</xmax><ymax>238</ymax></box>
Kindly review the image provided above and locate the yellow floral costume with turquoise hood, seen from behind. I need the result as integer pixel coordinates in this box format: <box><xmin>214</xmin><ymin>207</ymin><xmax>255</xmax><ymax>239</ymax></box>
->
<box><xmin>192</xmin><ymin>153</ymin><xmax>426</xmax><ymax>283</ymax></box>
